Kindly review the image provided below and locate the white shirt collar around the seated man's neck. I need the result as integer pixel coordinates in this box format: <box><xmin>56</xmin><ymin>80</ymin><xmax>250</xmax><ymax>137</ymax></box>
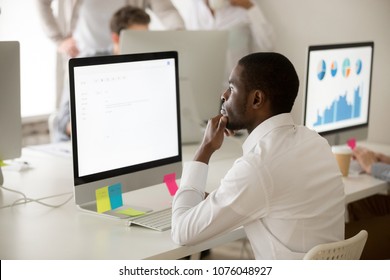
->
<box><xmin>242</xmin><ymin>113</ymin><xmax>295</xmax><ymax>155</ymax></box>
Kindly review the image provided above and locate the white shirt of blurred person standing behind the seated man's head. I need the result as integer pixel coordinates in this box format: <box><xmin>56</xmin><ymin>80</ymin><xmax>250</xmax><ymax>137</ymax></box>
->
<box><xmin>185</xmin><ymin>0</ymin><xmax>274</xmax><ymax>77</ymax></box>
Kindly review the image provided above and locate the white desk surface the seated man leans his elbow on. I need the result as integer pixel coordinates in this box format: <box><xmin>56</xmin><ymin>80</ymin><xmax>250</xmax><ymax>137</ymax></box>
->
<box><xmin>0</xmin><ymin>139</ymin><xmax>388</xmax><ymax>260</ymax></box>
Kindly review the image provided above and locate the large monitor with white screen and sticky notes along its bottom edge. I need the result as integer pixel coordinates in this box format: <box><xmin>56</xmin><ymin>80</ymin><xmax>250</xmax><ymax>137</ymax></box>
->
<box><xmin>69</xmin><ymin>52</ymin><xmax>182</xmax><ymax>218</ymax></box>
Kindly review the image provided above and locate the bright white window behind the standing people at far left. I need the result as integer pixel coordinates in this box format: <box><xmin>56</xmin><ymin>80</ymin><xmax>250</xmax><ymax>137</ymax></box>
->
<box><xmin>0</xmin><ymin>0</ymin><xmax>56</xmax><ymax>118</ymax></box>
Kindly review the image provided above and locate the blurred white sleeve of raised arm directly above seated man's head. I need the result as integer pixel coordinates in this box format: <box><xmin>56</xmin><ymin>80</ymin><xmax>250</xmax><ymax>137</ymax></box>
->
<box><xmin>248</xmin><ymin>4</ymin><xmax>275</xmax><ymax>51</ymax></box>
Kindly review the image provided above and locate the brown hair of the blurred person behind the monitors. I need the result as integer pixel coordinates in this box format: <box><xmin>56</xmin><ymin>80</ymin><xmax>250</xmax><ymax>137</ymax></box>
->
<box><xmin>110</xmin><ymin>5</ymin><xmax>150</xmax><ymax>34</ymax></box>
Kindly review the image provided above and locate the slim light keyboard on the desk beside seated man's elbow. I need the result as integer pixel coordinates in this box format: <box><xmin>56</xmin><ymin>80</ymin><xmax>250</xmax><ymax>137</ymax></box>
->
<box><xmin>129</xmin><ymin>208</ymin><xmax>172</xmax><ymax>231</ymax></box>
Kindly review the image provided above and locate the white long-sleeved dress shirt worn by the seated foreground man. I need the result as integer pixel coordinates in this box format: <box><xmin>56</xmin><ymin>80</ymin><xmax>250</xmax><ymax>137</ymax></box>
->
<box><xmin>172</xmin><ymin>114</ymin><xmax>345</xmax><ymax>259</ymax></box>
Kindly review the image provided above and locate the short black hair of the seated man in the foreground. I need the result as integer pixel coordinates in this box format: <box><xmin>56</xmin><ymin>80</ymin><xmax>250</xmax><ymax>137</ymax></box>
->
<box><xmin>238</xmin><ymin>52</ymin><xmax>299</xmax><ymax>115</ymax></box>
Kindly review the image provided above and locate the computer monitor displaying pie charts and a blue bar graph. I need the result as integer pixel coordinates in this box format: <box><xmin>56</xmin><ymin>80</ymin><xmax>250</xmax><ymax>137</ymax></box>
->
<box><xmin>304</xmin><ymin>42</ymin><xmax>374</xmax><ymax>145</ymax></box>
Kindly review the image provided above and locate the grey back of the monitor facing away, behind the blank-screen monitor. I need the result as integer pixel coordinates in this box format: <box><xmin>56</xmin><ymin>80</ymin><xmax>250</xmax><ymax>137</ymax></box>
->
<box><xmin>119</xmin><ymin>30</ymin><xmax>229</xmax><ymax>124</ymax></box>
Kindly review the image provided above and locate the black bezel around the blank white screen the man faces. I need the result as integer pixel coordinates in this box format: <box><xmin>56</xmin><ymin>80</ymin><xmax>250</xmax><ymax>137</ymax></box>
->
<box><xmin>69</xmin><ymin>51</ymin><xmax>182</xmax><ymax>186</ymax></box>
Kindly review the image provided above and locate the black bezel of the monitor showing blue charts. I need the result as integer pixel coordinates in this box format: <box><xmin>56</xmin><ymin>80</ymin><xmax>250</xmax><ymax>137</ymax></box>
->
<box><xmin>303</xmin><ymin>41</ymin><xmax>374</xmax><ymax>136</ymax></box>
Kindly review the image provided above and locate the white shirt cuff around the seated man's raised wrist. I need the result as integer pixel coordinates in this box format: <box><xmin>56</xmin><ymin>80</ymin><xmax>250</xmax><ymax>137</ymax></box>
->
<box><xmin>180</xmin><ymin>161</ymin><xmax>209</xmax><ymax>192</ymax></box>
